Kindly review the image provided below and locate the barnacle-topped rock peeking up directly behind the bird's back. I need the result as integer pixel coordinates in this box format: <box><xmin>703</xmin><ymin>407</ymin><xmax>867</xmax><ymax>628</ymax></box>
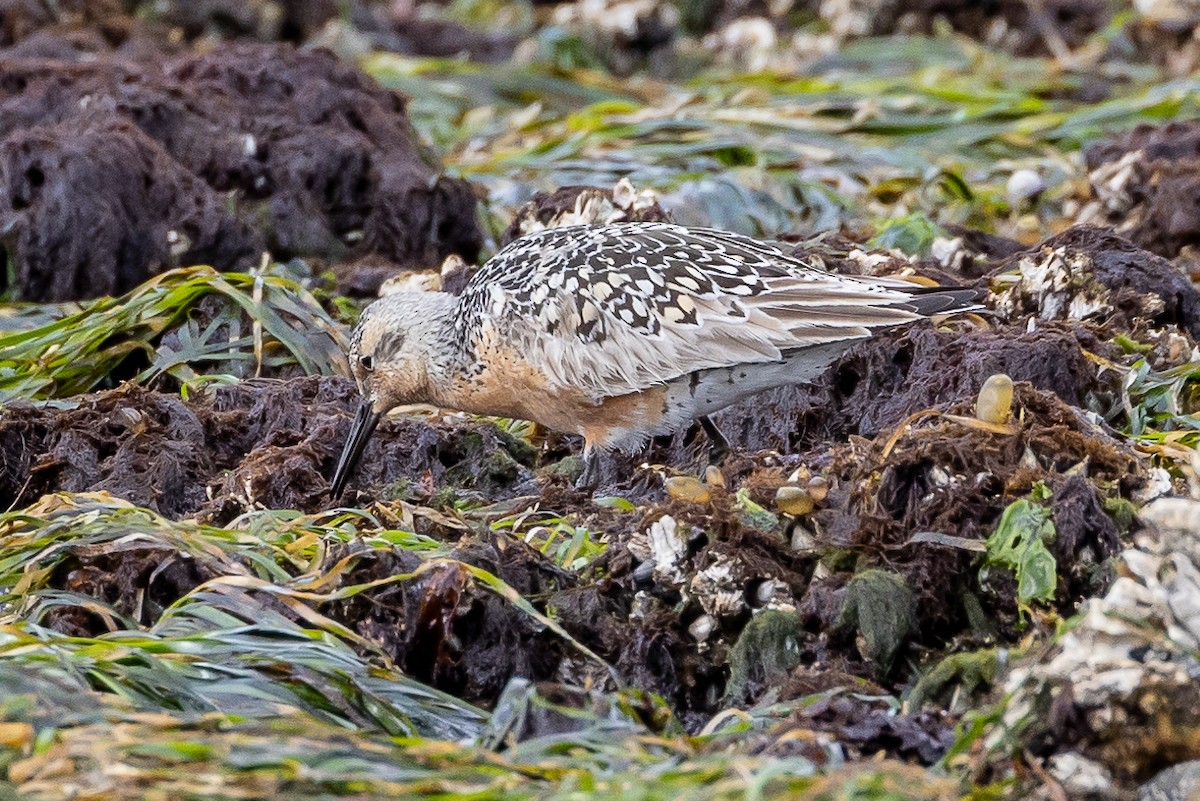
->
<box><xmin>500</xmin><ymin>179</ymin><xmax>672</xmax><ymax>246</ymax></box>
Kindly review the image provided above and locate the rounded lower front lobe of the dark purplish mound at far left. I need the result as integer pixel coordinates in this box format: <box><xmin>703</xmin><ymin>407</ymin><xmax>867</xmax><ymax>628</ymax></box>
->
<box><xmin>0</xmin><ymin>119</ymin><xmax>262</xmax><ymax>302</ymax></box>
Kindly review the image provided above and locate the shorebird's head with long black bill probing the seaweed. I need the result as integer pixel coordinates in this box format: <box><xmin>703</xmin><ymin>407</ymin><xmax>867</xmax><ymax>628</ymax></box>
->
<box><xmin>331</xmin><ymin>291</ymin><xmax>455</xmax><ymax>499</ymax></box>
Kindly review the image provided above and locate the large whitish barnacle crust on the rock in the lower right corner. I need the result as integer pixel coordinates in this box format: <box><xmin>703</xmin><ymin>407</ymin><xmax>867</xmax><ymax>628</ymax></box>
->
<box><xmin>988</xmin><ymin>498</ymin><xmax>1200</xmax><ymax>797</ymax></box>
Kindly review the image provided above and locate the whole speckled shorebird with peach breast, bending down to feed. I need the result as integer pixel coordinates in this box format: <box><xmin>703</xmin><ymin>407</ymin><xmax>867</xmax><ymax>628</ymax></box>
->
<box><xmin>331</xmin><ymin>223</ymin><xmax>976</xmax><ymax>499</ymax></box>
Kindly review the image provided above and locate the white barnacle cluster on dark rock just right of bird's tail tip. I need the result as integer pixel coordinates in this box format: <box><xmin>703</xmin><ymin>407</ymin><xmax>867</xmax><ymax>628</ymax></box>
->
<box><xmin>992</xmin><ymin>247</ymin><xmax>1112</xmax><ymax>320</ymax></box>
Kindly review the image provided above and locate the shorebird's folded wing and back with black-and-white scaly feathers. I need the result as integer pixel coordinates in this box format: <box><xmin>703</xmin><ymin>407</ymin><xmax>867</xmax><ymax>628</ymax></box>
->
<box><xmin>460</xmin><ymin>223</ymin><xmax>968</xmax><ymax>399</ymax></box>
